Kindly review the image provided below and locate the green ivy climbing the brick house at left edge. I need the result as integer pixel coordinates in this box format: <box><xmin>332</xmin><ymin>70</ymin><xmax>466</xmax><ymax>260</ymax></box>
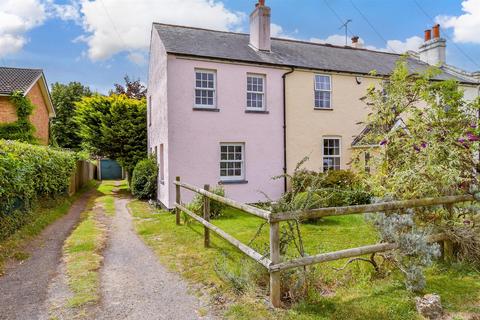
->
<box><xmin>0</xmin><ymin>91</ymin><xmax>37</xmax><ymax>143</ymax></box>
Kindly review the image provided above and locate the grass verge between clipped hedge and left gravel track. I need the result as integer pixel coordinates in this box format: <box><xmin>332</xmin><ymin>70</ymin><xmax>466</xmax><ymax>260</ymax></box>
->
<box><xmin>0</xmin><ymin>181</ymin><xmax>96</xmax><ymax>275</ymax></box>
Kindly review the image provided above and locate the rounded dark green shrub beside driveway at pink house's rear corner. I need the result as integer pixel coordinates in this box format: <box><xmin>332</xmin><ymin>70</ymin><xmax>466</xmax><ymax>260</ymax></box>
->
<box><xmin>131</xmin><ymin>157</ymin><xmax>158</xmax><ymax>199</ymax></box>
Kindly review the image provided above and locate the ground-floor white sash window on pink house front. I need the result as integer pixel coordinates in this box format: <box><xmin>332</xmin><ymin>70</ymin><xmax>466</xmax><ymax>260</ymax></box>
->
<box><xmin>220</xmin><ymin>143</ymin><xmax>245</xmax><ymax>181</ymax></box>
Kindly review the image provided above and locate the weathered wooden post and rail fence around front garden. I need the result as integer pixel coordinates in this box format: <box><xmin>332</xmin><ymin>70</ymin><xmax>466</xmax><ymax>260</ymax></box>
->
<box><xmin>174</xmin><ymin>177</ymin><xmax>475</xmax><ymax>307</ymax></box>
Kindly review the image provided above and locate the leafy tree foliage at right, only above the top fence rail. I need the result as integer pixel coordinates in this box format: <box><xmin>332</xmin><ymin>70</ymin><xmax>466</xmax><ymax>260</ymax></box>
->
<box><xmin>354</xmin><ymin>60</ymin><xmax>480</xmax><ymax>199</ymax></box>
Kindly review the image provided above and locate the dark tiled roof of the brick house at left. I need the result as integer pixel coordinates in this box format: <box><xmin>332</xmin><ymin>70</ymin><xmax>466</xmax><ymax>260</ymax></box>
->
<box><xmin>0</xmin><ymin>67</ymin><xmax>43</xmax><ymax>95</ymax></box>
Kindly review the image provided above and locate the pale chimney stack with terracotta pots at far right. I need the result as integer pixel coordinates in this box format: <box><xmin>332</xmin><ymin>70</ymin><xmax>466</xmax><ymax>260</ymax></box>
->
<box><xmin>419</xmin><ymin>24</ymin><xmax>447</xmax><ymax>66</ymax></box>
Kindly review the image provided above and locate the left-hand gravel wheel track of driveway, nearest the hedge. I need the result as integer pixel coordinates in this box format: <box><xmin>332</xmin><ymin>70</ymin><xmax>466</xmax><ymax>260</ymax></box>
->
<box><xmin>0</xmin><ymin>192</ymin><xmax>91</xmax><ymax>320</ymax></box>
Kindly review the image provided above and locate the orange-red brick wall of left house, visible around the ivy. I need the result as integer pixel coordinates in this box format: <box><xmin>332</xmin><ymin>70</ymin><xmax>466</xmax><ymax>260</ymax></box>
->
<box><xmin>0</xmin><ymin>82</ymin><xmax>49</xmax><ymax>144</ymax></box>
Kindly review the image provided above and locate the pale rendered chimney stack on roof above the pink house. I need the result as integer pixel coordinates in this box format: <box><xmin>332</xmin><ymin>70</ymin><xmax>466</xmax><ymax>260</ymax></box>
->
<box><xmin>250</xmin><ymin>0</ymin><xmax>271</xmax><ymax>52</ymax></box>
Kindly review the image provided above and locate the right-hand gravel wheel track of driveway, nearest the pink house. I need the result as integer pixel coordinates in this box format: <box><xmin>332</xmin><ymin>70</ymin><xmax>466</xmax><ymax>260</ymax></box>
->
<box><xmin>97</xmin><ymin>198</ymin><xmax>212</xmax><ymax>320</ymax></box>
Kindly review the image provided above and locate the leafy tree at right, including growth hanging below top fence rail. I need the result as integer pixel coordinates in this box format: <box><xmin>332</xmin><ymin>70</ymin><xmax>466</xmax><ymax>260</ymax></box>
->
<box><xmin>353</xmin><ymin>60</ymin><xmax>480</xmax><ymax>291</ymax></box>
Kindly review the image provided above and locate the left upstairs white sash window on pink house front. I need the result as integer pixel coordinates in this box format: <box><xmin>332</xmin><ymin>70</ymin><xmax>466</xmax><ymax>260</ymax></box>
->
<box><xmin>195</xmin><ymin>70</ymin><xmax>216</xmax><ymax>108</ymax></box>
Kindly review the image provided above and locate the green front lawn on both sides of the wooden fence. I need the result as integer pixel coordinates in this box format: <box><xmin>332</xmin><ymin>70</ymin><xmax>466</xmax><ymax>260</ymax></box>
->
<box><xmin>130</xmin><ymin>201</ymin><xmax>480</xmax><ymax>320</ymax></box>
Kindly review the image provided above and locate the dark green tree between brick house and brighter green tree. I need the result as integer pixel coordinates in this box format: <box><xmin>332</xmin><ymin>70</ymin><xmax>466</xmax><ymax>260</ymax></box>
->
<box><xmin>51</xmin><ymin>82</ymin><xmax>92</xmax><ymax>150</ymax></box>
